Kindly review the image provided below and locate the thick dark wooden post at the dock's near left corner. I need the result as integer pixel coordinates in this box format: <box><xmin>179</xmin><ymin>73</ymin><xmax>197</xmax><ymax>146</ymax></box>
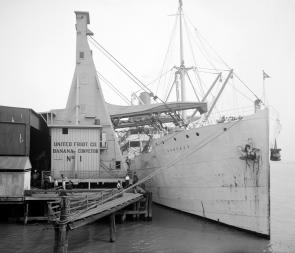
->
<box><xmin>54</xmin><ymin>196</ymin><xmax>69</xmax><ymax>253</ymax></box>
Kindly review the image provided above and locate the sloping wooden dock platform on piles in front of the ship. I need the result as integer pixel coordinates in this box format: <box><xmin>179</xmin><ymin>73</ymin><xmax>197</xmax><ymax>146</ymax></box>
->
<box><xmin>48</xmin><ymin>190</ymin><xmax>152</xmax><ymax>253</ymax></box>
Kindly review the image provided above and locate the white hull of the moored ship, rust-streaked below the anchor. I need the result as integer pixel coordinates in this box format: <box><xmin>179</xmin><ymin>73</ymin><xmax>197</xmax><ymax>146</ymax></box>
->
<box><xmin>132</xmin><ymin>109</ymin><xmax>270</xmax><ymax>236</ymax></box>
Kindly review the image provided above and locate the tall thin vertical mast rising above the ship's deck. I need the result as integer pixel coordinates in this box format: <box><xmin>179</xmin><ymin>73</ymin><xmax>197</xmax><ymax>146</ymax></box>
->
<box><xmin>178</xmin><ymin>0</ymin><xmax>186</xmax><ymax>119</ymax></box>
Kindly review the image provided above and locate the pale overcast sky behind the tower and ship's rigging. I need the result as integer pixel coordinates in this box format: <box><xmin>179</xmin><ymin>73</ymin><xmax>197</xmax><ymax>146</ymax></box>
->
<box><xmin>0</xmin><ymin>0</ymin><xmax>295</xmax><ymax>161</ymax></box>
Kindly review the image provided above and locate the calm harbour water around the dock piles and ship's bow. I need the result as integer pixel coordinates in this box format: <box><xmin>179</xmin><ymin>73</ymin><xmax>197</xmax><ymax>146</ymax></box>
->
<box><xmin>0</xmin><ymin>162</ymin><xmax>295</xmax><ymax>253</ymax></box>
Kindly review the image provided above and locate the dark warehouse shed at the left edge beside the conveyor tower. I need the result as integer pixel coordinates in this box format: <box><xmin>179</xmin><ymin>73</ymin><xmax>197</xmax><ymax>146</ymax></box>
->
<box><xmin>0</xmin><ymin>106</ymin><xmax>50</xmax><ymax>197</ymax></box>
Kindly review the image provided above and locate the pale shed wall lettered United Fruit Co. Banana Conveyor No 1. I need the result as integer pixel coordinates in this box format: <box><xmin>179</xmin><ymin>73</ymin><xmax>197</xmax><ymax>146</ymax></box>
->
<box><xmin>51</xmin><ymin>127</ymin><xmax>100</xmax><ymax>179</ymax></box>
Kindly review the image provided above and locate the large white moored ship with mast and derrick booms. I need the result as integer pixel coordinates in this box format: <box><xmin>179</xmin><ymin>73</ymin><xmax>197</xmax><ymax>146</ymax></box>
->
<box><xmin>117</xmin><ymin>0</ymin><xmax>277</xmax><ymax>238</ymax></box>
